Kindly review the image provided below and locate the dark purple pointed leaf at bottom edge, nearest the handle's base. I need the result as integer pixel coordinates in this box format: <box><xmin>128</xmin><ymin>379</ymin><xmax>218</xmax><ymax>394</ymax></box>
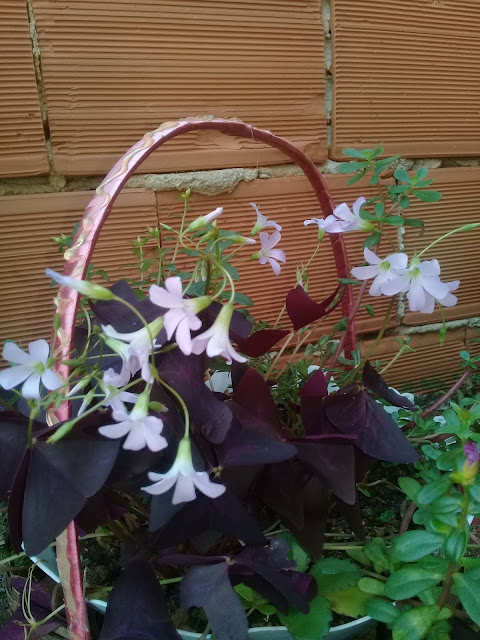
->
<box><xmin>99</xmin><ymin>560</ymin><xmax>180</xmax><ymax>640</ymax></box>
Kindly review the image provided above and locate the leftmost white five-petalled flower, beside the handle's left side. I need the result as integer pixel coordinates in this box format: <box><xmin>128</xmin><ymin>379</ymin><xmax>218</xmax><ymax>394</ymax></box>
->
<box><xmin>0</xmin><ymin>340</ymin><xmax>62</xmax><ymax>400</ymax></box>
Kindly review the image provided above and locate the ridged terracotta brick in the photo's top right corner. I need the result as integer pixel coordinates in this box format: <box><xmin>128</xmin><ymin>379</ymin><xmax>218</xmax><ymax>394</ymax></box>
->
<box><xmin>332</xmin><ymin>0</ymin><xmax>480</xmax><ymax>158</ymax></box>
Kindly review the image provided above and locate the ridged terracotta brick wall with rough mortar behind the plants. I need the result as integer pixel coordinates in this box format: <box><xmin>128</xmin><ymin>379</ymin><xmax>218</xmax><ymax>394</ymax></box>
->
<box><xmin>0</xmin><ymin>0</ymin><xmax>480</xmax><ymax>388</ymax></box>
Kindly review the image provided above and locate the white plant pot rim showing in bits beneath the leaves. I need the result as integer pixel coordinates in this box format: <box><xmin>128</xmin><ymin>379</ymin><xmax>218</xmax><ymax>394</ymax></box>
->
<box><xmin>30</xmin><ymin>547</ymin><xmax>373</xmax><ymax>640</ymax></box>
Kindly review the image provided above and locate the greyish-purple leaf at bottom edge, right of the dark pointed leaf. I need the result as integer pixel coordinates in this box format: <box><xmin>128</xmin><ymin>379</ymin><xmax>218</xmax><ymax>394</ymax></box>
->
<box><xmin>180</xmin><ymin>562</ymin><xmax>248</xmax><ymax>640</ymax></box>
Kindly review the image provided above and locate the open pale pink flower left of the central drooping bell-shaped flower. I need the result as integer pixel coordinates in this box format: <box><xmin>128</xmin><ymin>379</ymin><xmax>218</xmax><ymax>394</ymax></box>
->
<box><xmin>150</xmin><ymin>276</ymin><xmax>211</xmax><ymax>356</ymax></box>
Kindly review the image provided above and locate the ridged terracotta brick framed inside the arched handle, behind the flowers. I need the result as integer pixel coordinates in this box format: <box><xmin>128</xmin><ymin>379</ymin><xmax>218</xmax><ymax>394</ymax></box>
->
<box><xmin>157</xmin><ymin>175</ymin><xmax>395</xmax><ymax>334</ymax></box>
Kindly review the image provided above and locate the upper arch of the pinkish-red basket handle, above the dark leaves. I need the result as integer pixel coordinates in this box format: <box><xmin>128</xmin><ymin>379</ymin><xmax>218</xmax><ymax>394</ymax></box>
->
<box><xmin>53</xmin><ymin>117</ymin><xmax>356</xmax><ymax>402</ymax></box>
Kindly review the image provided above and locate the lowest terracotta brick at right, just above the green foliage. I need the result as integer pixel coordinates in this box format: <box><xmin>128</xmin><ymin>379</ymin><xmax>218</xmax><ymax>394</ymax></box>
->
<box><xmin>362</xmin><ymin>328</ymin><xmax>465</xmax><ymax>392</ymax></box>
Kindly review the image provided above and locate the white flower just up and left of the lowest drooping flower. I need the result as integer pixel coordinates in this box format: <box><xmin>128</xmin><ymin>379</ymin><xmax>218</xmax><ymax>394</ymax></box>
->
<box><xmin>98</xmin><ymin>391</ymin><xmax>167</xmax><ymax>451</ymax></box>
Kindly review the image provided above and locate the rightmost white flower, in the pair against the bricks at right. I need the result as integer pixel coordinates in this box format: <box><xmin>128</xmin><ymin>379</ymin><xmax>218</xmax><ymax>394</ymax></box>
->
<box><xmin>382</xmin><ymin>257</ymin><xmax>460</xmax><ymax>313</ymax></box>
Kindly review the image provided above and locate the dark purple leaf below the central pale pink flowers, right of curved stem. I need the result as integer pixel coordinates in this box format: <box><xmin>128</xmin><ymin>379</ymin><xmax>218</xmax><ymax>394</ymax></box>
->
<box><xmin>159</xmin><ymin>349</ymin><xmax>232</xmax><ymax>444</ymax></box>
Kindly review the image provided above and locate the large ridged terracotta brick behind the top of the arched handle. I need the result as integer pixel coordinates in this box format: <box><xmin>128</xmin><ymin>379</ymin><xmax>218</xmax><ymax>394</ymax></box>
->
<box><xmin>33</xmin><ymin>0</ymin><xmax>326</xmax><ymax>174</ymax></box>
